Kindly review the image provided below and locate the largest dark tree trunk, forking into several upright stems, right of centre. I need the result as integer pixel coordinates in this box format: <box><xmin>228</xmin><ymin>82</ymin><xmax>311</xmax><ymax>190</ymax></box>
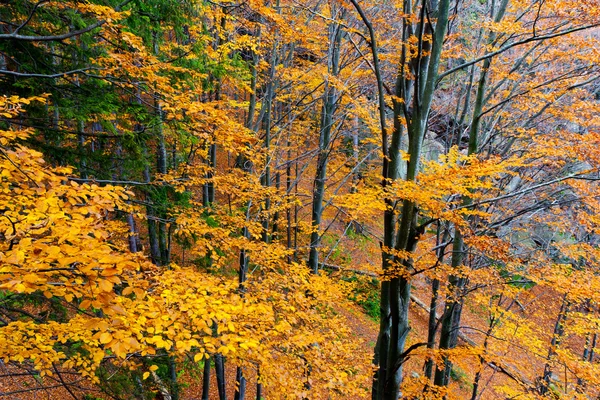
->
<box><xmin>352</xmin><ymin>0</ymin><xmax>450</xmax><ymax>400</ymax></box>
